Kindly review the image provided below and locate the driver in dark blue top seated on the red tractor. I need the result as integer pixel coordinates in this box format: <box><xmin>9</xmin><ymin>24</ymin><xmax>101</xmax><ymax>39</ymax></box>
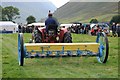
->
<box><xmin>45</xmin><ymin>11</ymin><xmax>58</xmax><ymax>34</ymax></box>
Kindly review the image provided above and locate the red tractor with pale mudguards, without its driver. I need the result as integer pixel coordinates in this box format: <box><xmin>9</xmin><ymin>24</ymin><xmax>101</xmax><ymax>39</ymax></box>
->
<box><xmin>33</xmin><ymin>27</ymin><xmax>72</xmax><ymax>43</ymax></box>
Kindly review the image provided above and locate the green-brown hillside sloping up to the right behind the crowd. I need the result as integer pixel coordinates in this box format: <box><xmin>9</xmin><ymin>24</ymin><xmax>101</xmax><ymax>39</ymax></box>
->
<box><xmin>54</xmin><ymin>2</ymin><xmax>118</xmax><ymax>23</ymax></box>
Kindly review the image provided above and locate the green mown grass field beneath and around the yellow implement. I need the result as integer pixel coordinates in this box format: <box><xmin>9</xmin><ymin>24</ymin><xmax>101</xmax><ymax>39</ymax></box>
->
<box><xmin>0</xmin><ymin>34</ymin><xmax>118</xmax><ymax>78</ymax></box>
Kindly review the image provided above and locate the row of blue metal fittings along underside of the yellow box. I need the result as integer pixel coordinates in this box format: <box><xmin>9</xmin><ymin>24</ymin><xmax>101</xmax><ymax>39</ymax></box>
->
<box><xmin>24</xmin><ymin>46</ymin><xmax>94</xmax><ymax>58</ymax></box>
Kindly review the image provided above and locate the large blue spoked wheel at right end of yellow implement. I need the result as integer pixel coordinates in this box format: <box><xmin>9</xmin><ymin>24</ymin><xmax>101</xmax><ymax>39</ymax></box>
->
<box><xmin>96</xmin><ymin>32</ymin><xmax>109</xmax><ymax>63</ymax></box>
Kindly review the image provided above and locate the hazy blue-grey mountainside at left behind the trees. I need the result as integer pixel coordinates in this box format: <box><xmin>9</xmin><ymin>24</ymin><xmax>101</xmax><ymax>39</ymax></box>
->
<box><xmin>2</xmin><ymin>1</ymin><xmax>56</xmax><ymax>23</ymax></box>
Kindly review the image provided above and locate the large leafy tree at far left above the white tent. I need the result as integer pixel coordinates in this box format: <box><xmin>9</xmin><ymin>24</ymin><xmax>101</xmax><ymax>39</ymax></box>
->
<box><xmin>2</xmin><ymin>6</ymin><xmax>20</xmax><ymax>21</ymax></box>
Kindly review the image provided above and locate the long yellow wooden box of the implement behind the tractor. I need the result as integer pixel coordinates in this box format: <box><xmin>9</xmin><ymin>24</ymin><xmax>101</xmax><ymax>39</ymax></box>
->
<box><xmin>24</xmin><ymin>43</ymin><xmax>99</xmax><ymax>53</ymax></box>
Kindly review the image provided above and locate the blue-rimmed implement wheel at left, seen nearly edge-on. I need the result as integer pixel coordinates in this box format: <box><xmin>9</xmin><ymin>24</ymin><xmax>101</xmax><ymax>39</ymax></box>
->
<box><xmin>18</xmin><ymin>33</ymin><xmax>24</xmax><ymax>66</ymax></box>
